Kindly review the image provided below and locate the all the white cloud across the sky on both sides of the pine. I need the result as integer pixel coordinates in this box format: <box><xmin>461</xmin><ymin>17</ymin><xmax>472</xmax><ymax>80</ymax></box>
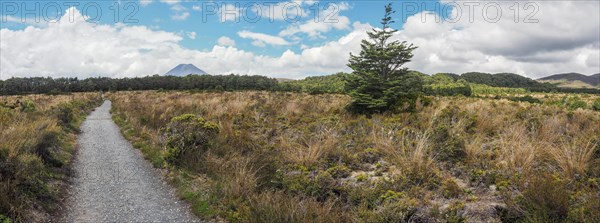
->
<box><xmin>0</xmin><ymin>2</ymin><xmax>600</xmax><ymax>79</ymax></box>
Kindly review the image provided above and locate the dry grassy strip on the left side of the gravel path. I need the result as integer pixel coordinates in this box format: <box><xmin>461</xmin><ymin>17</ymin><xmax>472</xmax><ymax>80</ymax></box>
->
<box><xmin>0</xmin><ymin>93</ymin><xmax>101</xmax><ymax>222</ymax></box>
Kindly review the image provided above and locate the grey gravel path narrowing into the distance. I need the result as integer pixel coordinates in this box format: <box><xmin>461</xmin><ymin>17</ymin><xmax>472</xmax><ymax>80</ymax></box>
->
<box><xmin>64</xmin><ymin>101</ymin><xmax>199</xmax><ymax>222</ymax></box>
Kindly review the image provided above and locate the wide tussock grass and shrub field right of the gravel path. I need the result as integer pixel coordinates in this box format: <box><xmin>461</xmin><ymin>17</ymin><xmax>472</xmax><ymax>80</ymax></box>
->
<box><xmin>109</xmin><ymin>91</ymin><xmax>600</xmax><ymax>222</ymax></box>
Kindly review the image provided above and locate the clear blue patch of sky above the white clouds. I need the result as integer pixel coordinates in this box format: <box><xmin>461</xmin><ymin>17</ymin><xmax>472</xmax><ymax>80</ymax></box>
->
<box><xmin>2</xmin><ymin>0</ymin><xmax>432</xmax><ymax>55</ymax></box>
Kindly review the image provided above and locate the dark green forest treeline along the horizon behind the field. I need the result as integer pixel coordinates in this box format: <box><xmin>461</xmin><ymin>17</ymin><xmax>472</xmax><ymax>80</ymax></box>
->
<box><xmin>0</xmin><ymin>71</ymin><xmax>600</xmax><ymax>96</ymax></box>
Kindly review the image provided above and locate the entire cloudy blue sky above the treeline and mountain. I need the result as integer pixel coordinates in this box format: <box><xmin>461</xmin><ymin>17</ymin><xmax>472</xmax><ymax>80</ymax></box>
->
<box><xmin>0</xmin><ymin>0</ymin><xmax>600</xmax><ymax>79</ymax></box>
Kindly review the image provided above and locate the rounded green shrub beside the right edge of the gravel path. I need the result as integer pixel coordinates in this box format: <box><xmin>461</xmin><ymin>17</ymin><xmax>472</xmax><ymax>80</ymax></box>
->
<box><xmin>163</xmin><ymin>114</ymin><xmax>219</xmax><ymax>164</ymax></box>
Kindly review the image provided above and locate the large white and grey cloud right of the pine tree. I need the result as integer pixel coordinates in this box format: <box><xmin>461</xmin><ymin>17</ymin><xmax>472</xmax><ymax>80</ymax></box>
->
<box><xmin>396</xmin><ymin>2</ymin><xmax>600</xmax><ymax>78</ymax></box>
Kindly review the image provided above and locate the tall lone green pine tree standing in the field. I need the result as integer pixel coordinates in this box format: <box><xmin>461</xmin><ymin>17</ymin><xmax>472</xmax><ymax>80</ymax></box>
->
<box><xmin>346</xmin><ymin>3</ymin><xmax>423</xmax><ymax>114</ymax></box>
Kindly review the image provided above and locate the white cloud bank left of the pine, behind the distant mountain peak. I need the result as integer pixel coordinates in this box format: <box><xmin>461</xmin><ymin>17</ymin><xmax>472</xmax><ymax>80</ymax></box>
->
<box><xmin>0</xmin><ymin>9</ymin><xmax>365</xmax><ymax>79</ymax></box>
